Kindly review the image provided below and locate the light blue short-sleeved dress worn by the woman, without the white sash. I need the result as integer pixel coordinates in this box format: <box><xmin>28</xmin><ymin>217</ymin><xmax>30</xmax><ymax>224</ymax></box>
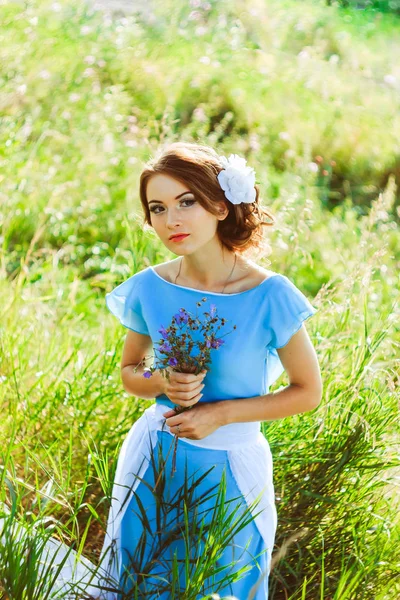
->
<box><xmin>106</xmin><ymin>267</ymin><xmax>317</xmax><ymax>600</ymax></box>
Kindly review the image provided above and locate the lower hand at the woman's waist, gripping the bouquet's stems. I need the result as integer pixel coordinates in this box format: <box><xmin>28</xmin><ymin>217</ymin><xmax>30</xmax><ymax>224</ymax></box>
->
<box><xmin>163</xmin><ymin>402</ymin><xmax>224</xmax><ymax>440</ymax></box>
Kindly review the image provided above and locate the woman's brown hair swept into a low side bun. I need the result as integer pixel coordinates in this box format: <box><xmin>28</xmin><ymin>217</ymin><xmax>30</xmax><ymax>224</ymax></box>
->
<box><xmin>140</xmin><ymin>142</ymin><xmax>275</xmax><ymax>262</ymax></box>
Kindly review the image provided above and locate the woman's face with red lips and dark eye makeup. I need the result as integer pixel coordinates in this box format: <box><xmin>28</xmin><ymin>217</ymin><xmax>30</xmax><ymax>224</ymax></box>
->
<box><xmin>146</xmin><ymin>173</ymin><xmax>228</xmax><ymax>254</ymax></box>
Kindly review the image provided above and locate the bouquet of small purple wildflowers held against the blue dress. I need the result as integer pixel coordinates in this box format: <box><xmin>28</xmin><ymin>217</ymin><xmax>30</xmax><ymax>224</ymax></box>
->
<box><xmin>134</xmin><ymin>297</ymin><xmax>236</xmax><ymax>474</ymax></box>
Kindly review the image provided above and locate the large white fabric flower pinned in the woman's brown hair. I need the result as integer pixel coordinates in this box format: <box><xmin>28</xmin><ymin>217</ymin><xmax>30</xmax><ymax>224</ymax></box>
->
<box><xmin>217</xmin><ymin>154</ymin><xmax>256</xmax><ymax>204</ymax></box>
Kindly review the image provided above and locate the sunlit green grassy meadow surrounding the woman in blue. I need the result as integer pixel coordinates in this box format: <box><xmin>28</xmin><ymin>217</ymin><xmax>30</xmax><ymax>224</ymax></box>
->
<box><xmin>0</xmin><ymin>0</ymin><xmax>400</xmax><ymax>600</ymax></box>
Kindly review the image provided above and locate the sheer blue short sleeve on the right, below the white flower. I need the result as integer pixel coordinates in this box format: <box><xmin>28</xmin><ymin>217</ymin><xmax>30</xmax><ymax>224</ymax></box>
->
<box><xmin>267</xmin><ymin>275</ymin><xmax>317</xmax><ymax>349</ymax></box>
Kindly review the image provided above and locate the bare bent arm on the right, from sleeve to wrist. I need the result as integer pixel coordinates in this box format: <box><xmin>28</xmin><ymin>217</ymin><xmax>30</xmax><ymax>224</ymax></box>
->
<box><xmin>215</xmin><ymin>323</ymin><xmax>322</xmax><ymax>425</ymax></box>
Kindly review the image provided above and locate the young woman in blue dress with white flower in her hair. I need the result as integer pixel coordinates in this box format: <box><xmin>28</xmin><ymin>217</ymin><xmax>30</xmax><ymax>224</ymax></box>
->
<box><xmin>97</xmin><ymin>142</ymin><xmax>322</xmax><ymax>600</ymax></box>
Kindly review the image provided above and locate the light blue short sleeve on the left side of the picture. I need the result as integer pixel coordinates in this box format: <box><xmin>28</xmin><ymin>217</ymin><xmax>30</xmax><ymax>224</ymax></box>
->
<box><xmin>105</xmin><ymin>275</ymin><xmax>150</xmax><ymax>335</ymax></box>
